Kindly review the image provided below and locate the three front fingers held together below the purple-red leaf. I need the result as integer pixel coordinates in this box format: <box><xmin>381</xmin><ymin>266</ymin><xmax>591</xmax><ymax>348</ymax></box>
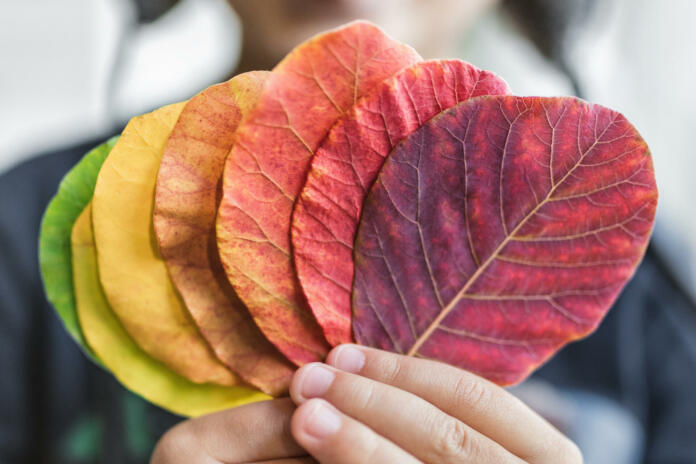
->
<box><xmin>290</xmin><ymin>345</ymin><xmax>582</xmax><ymax>464</ymax></box>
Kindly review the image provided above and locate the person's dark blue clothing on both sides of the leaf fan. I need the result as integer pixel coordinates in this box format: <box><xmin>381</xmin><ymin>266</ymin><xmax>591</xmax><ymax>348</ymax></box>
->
<box><xmin>0</xmin><ymin>141</ymin><xmax>696</xmax><ymax>464</ymax></box>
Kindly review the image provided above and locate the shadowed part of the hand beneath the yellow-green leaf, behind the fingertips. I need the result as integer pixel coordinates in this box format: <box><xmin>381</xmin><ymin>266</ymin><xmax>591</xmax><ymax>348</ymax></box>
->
<box><xmin>151</xmin><ymin>398</ymin><xmax>304</xmax><ymax>464</ymax></box>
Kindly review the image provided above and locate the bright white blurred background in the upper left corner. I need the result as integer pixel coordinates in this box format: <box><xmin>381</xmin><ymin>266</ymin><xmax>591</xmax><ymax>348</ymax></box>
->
<box><xmin>0</xmin><ymin>0</ymin><xmax>240</xmax><ymax>172</ymax></box>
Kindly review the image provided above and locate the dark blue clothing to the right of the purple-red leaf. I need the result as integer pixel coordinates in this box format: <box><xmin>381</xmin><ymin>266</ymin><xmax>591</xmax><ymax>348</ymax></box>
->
<box><xmin>535</xmin><ymin>254</ymin><xmax>696</xmax><ymax>464</ymax></box>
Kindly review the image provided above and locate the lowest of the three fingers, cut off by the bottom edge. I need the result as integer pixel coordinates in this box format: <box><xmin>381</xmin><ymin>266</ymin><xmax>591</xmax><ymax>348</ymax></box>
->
<box><xmin>292</xmin><ymin>399</ymin><xmax>419</xmax><ymax>464</ymax></box>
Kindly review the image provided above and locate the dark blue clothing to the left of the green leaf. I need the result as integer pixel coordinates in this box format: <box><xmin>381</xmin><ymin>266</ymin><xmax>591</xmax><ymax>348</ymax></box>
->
<box><xmin>0</xmin><ymin>141</ymin><xmax>180</xmax><ymax>464</ymax></box>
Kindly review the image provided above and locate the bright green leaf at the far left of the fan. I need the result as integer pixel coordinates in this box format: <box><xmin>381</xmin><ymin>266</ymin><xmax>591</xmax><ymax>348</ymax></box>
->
<box><xmin>39</xmin><ymin>137</ymin><xmax>118</xmax><ymax>363</ymax></box>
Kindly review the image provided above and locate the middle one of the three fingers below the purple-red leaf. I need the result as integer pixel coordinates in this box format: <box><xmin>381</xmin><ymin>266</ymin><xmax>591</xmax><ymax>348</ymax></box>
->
<box><xmin>290</xmin><ymin>363</ymin><xmax>521</xmax><ymax>464</ymax></box>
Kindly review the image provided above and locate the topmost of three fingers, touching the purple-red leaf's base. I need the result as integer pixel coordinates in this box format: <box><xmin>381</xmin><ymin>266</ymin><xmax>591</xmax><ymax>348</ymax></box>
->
<box><xmin>327</xmin><ymin>345</ymin><xmax>582</xmax><ymax>464</ymax></box>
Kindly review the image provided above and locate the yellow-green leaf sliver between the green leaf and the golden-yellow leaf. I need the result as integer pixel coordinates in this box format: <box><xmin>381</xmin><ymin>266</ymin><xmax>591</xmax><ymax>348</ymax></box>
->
<box><xmin>72</xmin><ymin>204</ymin><xmax>269</xmax><ymax>416</ymax></box>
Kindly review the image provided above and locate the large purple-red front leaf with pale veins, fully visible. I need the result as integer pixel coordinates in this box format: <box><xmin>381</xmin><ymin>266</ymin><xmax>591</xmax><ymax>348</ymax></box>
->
<box><xmin>353</xmin><ymin>96</ymin><xmax>657</xmax><ymax>384</ymax></box>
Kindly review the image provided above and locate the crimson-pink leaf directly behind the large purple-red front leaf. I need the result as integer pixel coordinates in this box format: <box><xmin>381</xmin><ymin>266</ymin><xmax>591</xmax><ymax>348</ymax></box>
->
<box><xmin>292</xmin><ymin>60</ymin><xmax>508</xmax><ymax>346</ymax></box>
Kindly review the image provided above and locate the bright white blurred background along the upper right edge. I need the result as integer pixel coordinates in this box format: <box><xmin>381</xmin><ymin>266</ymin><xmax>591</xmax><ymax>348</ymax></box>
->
<box><xmin>573</xmin><ymin>0</ymin><xmax>696</xmax><ymax>298</ymax></box>
